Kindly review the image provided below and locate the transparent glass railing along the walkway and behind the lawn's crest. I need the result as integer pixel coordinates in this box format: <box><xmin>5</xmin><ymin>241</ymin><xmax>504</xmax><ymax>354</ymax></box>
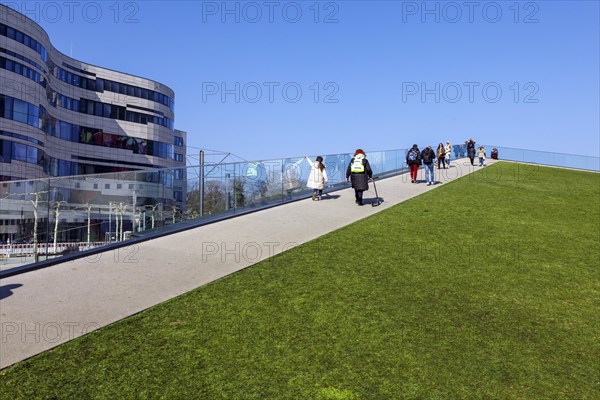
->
<box><xmin>0</xmin><ymin>145</ymin><xmax>600</xmax><ymax>270</ymax></box>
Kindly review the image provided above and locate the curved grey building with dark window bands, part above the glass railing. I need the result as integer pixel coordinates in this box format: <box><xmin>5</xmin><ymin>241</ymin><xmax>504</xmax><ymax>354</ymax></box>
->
<box><xmin>0</xmin><ymin>5</ymin><xmax>186</xmax><ymax>181</ymax></box>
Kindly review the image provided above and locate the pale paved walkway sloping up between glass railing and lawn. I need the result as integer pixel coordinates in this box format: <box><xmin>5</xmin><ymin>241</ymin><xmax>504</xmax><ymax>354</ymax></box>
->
<box><xmin>0</xmin><ymin>159</ymin><xmax>492</xmax><ymax>368</ymax></box>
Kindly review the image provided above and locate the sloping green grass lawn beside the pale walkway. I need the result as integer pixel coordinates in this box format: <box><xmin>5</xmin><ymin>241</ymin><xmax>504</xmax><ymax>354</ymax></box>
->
<box><xmin>0</xmin><ymin>163</ymin><xmax>600</xmax><ymax>400</ymax></box>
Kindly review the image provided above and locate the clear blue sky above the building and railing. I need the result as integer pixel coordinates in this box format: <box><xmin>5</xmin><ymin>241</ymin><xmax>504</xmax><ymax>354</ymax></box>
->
<box><xmin>3</xmin><ymin>1</ymin><xmax>600</xmax><ymax>159</ymax></box>
